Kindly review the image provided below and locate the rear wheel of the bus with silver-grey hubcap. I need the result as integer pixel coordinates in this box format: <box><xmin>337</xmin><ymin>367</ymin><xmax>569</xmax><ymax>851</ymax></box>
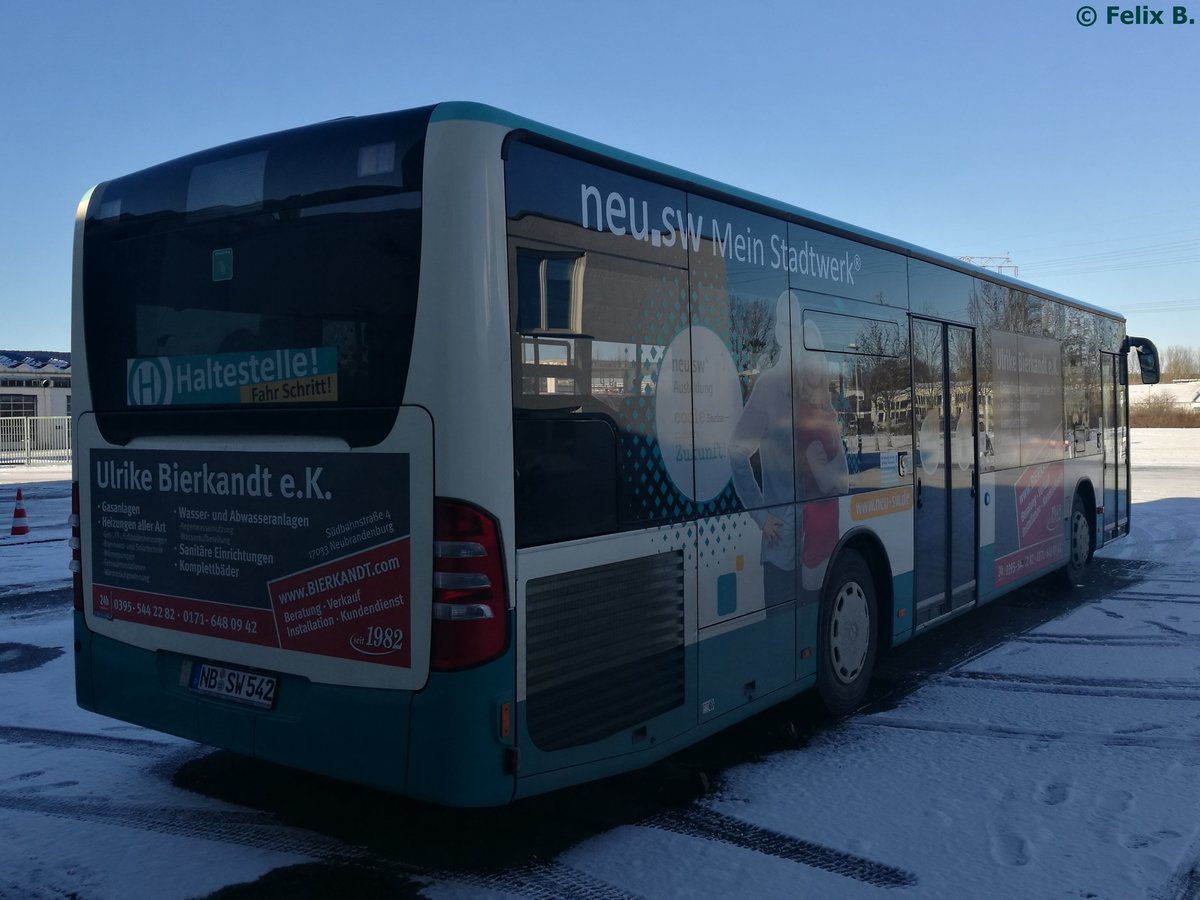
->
<box><xmin>817</xmin><ymin>550</ymin><xmax>878</xmax><ymax>716</ymax></box>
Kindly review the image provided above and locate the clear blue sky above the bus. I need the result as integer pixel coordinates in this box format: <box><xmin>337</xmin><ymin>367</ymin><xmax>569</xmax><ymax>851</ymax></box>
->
<box><xmin>0</xmin><ymin>0</ymin><xmax>1200</xmax><ymax>350</ymax></box>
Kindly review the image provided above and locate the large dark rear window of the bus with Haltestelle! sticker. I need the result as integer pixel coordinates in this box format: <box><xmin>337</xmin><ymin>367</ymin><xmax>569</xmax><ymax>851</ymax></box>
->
<box><xmin>83</xmin><ymin>109</ymin><xmax>430</xmax><ymax>412</ymax></box>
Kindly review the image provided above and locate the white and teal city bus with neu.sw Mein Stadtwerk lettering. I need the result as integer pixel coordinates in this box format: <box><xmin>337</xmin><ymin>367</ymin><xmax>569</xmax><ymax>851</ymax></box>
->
<box><xmin>72</xmin><ymin>102</ymin><xmax>1158</xmax><ymax>806</ymax></box>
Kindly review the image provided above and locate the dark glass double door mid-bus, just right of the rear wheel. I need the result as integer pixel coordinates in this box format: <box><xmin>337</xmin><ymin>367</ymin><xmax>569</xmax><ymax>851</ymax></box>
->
<box><xmin>912</xmin><ymin>319</ymin><xmax>978</xmax><ymax>628</ymax></box>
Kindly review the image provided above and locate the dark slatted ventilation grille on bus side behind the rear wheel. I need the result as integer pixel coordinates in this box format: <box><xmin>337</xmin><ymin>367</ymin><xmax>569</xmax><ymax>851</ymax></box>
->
<box><xmin>526</xmin><ymin>551</ymin><xmax>684</xmax><ymax>750</ymax></box>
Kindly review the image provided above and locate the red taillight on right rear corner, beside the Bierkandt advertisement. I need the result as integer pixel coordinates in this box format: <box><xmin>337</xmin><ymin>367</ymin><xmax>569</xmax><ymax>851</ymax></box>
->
<box><xmin>430</xmin><ymin>500</ymin><xmax>509</xmax><ymax>672</ymax></box>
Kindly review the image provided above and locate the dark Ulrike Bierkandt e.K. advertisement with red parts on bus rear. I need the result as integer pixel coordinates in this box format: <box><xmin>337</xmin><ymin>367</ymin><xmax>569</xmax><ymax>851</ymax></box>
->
<box><xmin>88</xmin><ymin>450</ymin><xmax>412</xmax><ymax>667</ymax></box>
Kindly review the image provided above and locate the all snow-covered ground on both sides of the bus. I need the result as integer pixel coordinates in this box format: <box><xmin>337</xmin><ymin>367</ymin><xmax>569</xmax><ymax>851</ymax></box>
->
<box><xmin>0</xmin><ymin>430</ymin><xmax>1200</xmax><ymax>900</ymax></box>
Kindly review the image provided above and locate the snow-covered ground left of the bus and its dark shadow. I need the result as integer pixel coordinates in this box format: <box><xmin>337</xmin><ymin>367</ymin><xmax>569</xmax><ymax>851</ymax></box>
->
<box><xmin>0</xmin><ymin>467</ymin><xmax>308</xmax><ymax>900</ymax></box>
